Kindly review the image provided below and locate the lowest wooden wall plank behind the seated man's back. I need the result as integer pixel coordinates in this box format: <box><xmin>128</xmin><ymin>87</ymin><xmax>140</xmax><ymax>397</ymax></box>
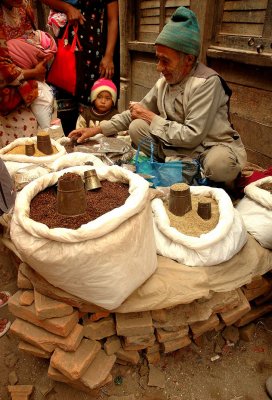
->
<box><xmin>231</xmin><ymin>113</ymin><xmax>272</xmax><ymax>157</ymax></box>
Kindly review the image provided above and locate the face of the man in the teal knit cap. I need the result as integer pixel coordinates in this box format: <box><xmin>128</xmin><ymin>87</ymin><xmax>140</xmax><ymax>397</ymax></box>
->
<box><xmin>156</xmin><ymin>44</ymin><xmax>193</xmax><ymax>85</ymax></box>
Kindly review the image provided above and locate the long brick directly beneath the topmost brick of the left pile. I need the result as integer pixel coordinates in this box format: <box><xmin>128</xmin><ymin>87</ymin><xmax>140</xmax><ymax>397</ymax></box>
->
<box><xmin>8</xmin><ymin>290</ymin><xmax>78</xmax><ymax>337</ymax></box>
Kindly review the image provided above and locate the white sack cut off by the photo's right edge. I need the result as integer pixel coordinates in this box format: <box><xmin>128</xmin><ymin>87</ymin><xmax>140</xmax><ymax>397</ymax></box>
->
<box><xmin>236</xmin><ymin>176</ymin><xmax>272</xmax><ymax>249</ymax></box>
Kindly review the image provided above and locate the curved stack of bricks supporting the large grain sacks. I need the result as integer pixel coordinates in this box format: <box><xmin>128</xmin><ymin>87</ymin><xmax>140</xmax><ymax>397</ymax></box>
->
<box><xmin>9</xmin><ymin>264</ymin><xmax>272</xmax><ymax>394</ymax></box>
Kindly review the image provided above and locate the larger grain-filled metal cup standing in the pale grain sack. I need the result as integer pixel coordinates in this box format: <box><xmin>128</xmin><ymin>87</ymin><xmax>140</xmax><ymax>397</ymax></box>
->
<box><xmin>169</xmin><ymin>183</ymin><xmax>192</xmax><ymax>217</ymax></box>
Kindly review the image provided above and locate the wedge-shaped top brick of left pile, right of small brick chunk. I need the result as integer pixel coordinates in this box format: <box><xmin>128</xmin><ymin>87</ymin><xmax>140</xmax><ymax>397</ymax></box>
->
<box><xmin>34</xmin><ymin>290</ymin><xmax>74</xmax><ymax>319</ymax></box>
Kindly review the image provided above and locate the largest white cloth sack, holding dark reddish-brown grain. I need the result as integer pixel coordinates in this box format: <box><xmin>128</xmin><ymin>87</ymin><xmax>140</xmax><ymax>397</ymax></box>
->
<box><xmin>11</xmin><ymin>166</ymin><xmax>157</xmax><ymax>310</ymax></box>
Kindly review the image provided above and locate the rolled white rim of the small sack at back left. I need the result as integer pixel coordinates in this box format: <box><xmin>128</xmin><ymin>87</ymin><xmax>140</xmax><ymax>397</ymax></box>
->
<box><xmin>0</xmin><ymin>137</ymin><xmax>66</xmax><ymax>164</ymax></box>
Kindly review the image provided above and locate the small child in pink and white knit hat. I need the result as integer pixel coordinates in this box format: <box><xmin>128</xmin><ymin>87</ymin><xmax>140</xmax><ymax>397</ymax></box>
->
<box><xmin>76</xmin><ymin>78</ymin><xmax>118</xmax><ymax>129</ymax></box>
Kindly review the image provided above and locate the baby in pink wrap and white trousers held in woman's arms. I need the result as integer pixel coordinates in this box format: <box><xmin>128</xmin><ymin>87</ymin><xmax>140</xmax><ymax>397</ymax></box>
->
<box><xmin>7</xmin><ymin>30</ymin><xmax>57</xmax><ymax>129</ymax></box>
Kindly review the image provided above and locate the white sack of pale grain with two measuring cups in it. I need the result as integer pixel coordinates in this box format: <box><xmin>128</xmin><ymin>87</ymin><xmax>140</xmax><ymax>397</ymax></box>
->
<box><xmin>151</xmin><ymin>186</ymin><xmax>247</xmax><ymax>267</ymax></box>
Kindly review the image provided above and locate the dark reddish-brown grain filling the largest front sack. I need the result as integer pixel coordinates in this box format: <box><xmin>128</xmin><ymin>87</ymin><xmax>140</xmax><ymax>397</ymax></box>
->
<box><xmin>29</xmin><ymin>180</ymin><xmax>129</xmax><ymax>229</ymax></box>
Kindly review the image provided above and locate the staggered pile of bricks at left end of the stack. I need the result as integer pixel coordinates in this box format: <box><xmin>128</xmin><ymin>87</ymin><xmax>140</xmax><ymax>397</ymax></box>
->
<box><xmin>9</xmin><ymin>289</ymin><xmax>116</xmax><ymax>394</ymax></box>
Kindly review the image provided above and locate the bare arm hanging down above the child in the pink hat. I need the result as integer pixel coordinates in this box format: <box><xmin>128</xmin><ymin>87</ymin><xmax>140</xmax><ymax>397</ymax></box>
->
<box><xmin>99</xmin><ymin>1</ymin><xmax>119</xmax><ymax>79</ymax></box>
